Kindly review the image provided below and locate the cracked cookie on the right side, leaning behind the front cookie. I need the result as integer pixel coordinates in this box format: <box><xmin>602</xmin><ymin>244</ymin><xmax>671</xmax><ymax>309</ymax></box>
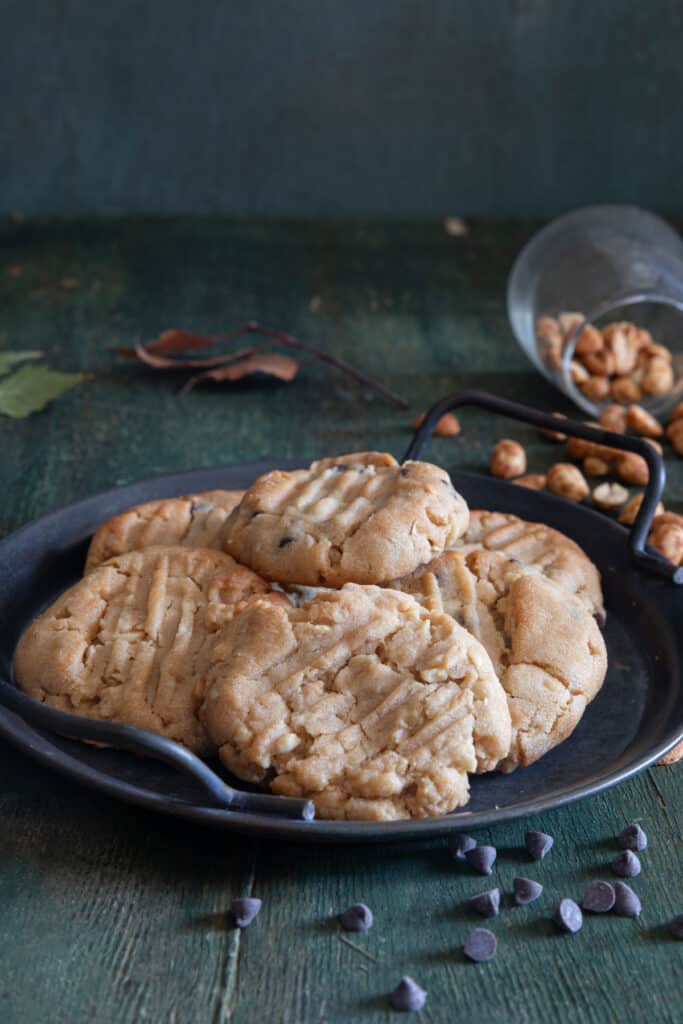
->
<box><xmin>392</xmin><ymin>549</ymin><xmax>607</xmax><ymax>771</ymax></box>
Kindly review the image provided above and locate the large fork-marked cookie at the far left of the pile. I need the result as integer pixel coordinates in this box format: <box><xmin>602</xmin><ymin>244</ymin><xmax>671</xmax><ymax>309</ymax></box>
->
<box><xmin>14</xmin><ymin>547</ymin><xmax>270</xmax><ymax>755</ymax></box>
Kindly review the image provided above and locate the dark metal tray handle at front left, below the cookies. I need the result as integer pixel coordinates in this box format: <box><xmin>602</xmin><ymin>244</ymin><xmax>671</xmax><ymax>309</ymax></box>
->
<box><xmin>0</xmin><ymin>679</ymin><xmax>314</xmax><ymax>821</ymax></box>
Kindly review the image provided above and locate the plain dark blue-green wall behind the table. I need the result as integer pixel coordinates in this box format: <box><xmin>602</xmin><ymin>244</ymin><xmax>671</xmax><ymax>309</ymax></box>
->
<box><xmin>0</xmin><ymin>0</ymin><xmax>683</xmax><ymax>216</ymax></box>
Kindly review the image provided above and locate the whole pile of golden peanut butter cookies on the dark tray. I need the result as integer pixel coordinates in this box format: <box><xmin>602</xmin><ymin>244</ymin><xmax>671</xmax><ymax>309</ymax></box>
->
<box><xmin>15</xmin><ymin>453</ymin><xmax>606</xmax><ymax>820</ymax></box>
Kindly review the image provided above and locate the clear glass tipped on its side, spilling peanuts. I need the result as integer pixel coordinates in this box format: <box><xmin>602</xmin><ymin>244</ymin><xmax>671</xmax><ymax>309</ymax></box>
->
<box><xmin>508</xmin><ymin>206</ymin><xmax>683</xmax><ymax>417</ymax></box>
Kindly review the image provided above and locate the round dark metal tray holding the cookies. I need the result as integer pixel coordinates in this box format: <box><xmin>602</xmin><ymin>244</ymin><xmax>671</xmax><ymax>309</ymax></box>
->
<box><xmin>0</xmin><ymin>463</ymin><xmax>683</xmax><ymax>842</ymax></box>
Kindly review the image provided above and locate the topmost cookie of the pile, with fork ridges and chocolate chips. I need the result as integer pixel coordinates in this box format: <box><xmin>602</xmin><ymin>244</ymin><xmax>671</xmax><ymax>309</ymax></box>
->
<box><xmin>225</xmin><ymin>452</ymin><xmax>468</xmax><ymax>586</ymax></box>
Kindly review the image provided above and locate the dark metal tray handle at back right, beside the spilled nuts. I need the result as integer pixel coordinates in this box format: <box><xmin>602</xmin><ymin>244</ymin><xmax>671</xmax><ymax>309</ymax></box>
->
<box><xmin>403</xmin><ymin>391</ymin><xmax>683</xmax><ymax>585</ymax></box>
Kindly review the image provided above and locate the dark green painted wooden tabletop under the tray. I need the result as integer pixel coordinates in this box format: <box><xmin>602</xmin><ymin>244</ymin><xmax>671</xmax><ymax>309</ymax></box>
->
<box><xmin>0</xmin><ymin>220</ymin><xmax>683</xmax><ymax>1024</ymax></box>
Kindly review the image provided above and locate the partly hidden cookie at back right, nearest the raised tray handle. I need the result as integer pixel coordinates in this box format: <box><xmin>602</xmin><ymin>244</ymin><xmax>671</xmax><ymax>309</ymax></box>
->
<box><xmin>456</xmin><ymin>509</ymin><xmax>605</xmax><ymax>623</ymax></box>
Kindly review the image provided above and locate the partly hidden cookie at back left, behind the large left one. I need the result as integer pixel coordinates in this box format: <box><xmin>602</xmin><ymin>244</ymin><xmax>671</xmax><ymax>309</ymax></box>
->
<box><xmin>85</xmin><ymin>490</ymin><xmax>244</xmax><ymax>572</ymax></box>
